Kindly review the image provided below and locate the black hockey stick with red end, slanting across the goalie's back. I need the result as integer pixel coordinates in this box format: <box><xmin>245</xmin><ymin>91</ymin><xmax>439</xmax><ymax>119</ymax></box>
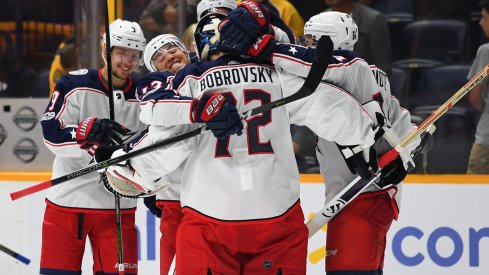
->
<box><xmin>10</xmin><ymin>36</ymin><xmax>333</xmax><ymax>200</ymax></box>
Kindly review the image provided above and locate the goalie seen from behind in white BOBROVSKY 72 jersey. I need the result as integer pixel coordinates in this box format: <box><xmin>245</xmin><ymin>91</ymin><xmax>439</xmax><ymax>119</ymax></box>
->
<box><xmin>101</xmin><ymin>11</ymin><xmax>402</xmax><ymax>274</ymax></box>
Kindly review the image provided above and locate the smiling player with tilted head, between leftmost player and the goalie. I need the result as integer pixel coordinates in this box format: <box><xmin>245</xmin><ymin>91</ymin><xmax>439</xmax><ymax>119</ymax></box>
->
<box><xmin>137</xmin><ymin>34</ymin><xmax>190</xmax><ymax>275</ymax></box>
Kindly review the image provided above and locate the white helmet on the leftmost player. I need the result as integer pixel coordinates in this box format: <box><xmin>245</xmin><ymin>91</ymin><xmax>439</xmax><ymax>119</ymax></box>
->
<box><xmin>103</xmin><ymin>19</ymin><xmax>146</xmax><ymax>52</ymax></box>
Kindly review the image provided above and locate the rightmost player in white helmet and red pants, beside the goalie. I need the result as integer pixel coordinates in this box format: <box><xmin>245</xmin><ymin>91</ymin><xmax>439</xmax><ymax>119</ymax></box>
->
<box><xmin>304</xmin><ymin>12</ymin><xmax>416</xmax><ymax>275</ymax></box>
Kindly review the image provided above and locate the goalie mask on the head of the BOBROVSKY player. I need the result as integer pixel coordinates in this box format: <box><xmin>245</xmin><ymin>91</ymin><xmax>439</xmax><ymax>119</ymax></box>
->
<box><xmin>194</xmin><ymin>13</ymin><xmax>226</xmax><ymax>61</ymax></box>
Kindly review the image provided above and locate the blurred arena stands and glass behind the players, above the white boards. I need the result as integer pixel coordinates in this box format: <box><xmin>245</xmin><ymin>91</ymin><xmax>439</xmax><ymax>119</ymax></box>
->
<box><xmin>0</xmin><ymin>0</ymin><xmax>488</xmax><ymax>174</ymax></box>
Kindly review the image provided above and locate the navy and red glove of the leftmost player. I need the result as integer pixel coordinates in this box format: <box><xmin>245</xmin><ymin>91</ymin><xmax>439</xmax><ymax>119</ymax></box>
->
<box><xmin>76</xmin><ymin>117</ymin><xmax>130</xmax><ymax>152</ymax></box>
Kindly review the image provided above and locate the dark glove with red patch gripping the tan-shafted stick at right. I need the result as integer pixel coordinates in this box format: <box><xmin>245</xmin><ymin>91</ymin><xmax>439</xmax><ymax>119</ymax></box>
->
<box><xmin>376</xmin><ymin>148</ymin><xmax>408</xmax><ymax>188</ymax></box>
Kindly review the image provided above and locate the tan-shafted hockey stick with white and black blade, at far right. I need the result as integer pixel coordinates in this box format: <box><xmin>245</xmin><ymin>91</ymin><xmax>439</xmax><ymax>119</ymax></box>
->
<box><xmin>307</xmin><ymin>64</ymin><xmax>489</xmax><ymax>238</ymax></box>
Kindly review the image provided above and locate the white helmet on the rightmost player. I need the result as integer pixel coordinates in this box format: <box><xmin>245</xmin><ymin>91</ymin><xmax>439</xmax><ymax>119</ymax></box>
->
<box><xmin>304</xmin><ymin>11</ymin><xmax>358</xmax><ymax>50</ymax></box>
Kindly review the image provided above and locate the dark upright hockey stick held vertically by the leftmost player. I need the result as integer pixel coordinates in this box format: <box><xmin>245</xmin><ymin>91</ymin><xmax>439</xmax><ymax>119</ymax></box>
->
<box><xmin>104</xmin><ymin>0</ymin><xmax>125</xmax><ymax>275</ymax></box>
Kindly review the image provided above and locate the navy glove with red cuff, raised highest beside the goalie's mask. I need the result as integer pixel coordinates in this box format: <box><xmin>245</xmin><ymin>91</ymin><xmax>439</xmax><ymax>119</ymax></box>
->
<box><xmin>219</xmin><ymin>1</ymin><xmax>273</xmax><ymax>55</ymax></box>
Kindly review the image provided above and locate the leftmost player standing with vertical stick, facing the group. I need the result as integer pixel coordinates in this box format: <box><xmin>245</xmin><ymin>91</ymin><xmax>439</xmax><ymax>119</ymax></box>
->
<box><xmin>40</xmin><ymin>19</ymin><xmax>146</xmax><ymax>275</ymax></box>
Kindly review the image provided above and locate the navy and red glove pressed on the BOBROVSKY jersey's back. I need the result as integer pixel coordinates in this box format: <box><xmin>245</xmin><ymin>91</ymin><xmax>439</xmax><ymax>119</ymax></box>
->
<box><xmin>193</xmin><ymin>94</ymin><xmax>243</xmax><ymax>139</ymax></box>
